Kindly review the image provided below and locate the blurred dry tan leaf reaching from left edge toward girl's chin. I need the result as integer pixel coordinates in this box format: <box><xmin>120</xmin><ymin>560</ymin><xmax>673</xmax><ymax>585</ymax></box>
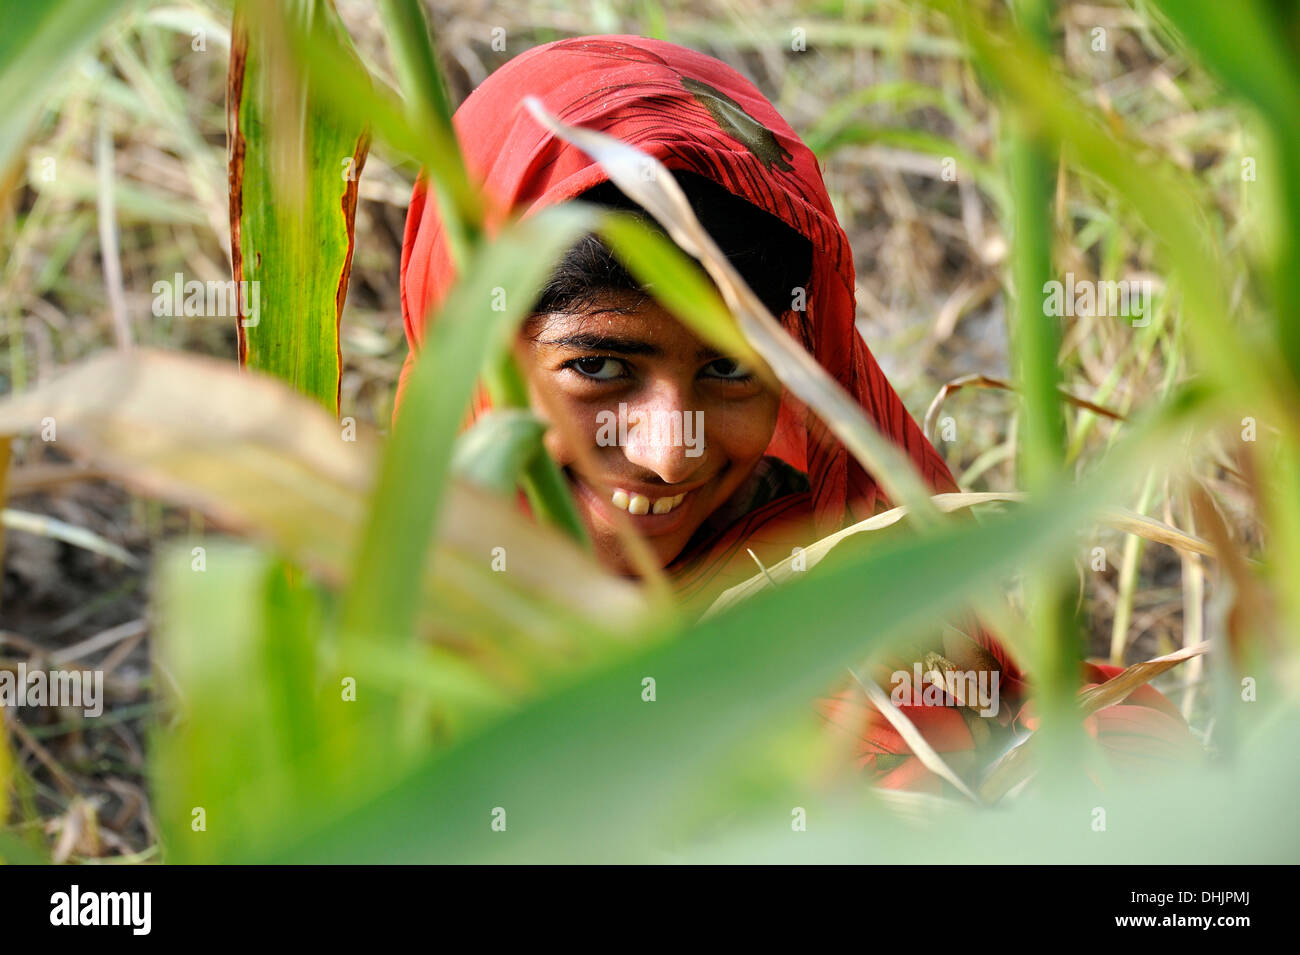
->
<box><xmin>0</xmin><ymin>350</ymin><xmax>645</xmax><ymax>641</ymax></box>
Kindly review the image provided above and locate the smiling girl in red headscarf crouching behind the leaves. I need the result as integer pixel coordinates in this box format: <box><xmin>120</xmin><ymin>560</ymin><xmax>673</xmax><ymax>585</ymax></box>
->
<box><xmin>402</xmin><ymin>36</ymin><xmax>1191</xmax><ymax>789</ymax></box>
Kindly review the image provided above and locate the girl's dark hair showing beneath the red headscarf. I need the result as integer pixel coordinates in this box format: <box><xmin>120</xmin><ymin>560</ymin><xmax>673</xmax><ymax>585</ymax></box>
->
<box><xmin>533</xmin><ymin>170</ymin><xmax>813</xmax><ymax>316</ymax></box>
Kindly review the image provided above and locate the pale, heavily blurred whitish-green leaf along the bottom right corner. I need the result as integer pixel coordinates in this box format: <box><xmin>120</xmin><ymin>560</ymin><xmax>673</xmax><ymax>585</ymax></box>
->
<box><xmin>667</xmin><ymin>703</ymin><xmax>1300</xmax><ymax>867</ymax></box>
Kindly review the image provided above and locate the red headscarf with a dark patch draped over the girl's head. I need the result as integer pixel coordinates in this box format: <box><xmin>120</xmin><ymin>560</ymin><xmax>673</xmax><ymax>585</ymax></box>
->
<box><xmin>402</xmin><ymin>36</ymin><xmax>957</xmax><ymax>566</ymax></box>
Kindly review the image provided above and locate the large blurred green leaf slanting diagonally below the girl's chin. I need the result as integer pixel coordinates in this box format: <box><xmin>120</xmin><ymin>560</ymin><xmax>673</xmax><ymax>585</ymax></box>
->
<box><xmin>261</xmin><ymin>462</ymin><xmax>1149</xmax><ymax>863</ymax></box>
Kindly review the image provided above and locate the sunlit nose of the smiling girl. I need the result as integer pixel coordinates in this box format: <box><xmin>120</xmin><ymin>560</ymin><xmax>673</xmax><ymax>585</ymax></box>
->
<box><xmin>623</xmin><ymin>381</ymin><xmax>703</xmax><ymax>485</ymax></box>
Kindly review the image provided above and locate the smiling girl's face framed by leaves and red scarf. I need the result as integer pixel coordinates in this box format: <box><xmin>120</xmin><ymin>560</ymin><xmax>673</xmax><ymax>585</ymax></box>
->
<box><xmin>519</xmin><ymin>292</ymin><xmax>780</xmax><ymax>573</ymax></box>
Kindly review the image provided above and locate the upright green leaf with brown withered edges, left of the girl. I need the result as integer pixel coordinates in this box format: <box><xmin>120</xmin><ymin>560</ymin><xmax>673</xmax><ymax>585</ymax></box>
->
<box><xmin>228</xmin><ymin>0</ymin><xmax>369</xmax><ymax>414</ymax></box>
